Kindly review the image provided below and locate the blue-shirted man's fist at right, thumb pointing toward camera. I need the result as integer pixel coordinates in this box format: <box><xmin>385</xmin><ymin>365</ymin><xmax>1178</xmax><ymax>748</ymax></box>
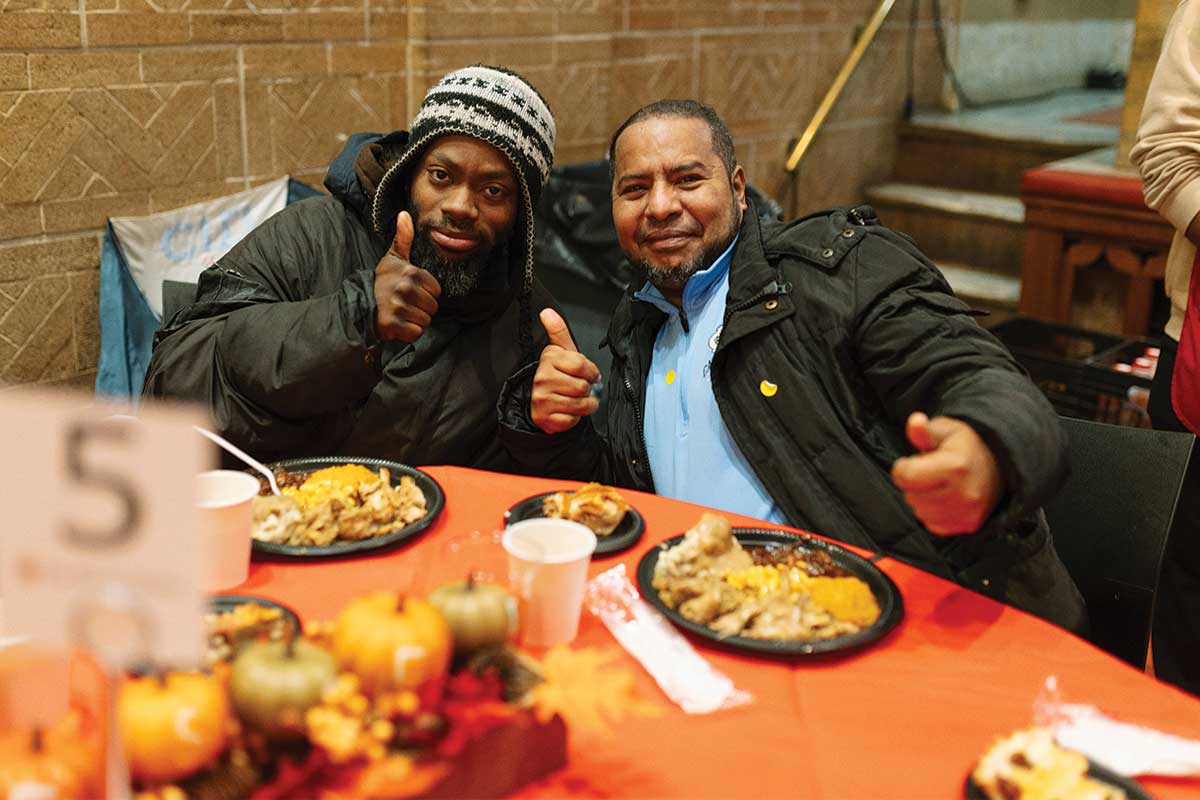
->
<box><xmin>892</xmin><ymin>411</ymin><xmax>1004</xmax><ymax>536</ymax></box>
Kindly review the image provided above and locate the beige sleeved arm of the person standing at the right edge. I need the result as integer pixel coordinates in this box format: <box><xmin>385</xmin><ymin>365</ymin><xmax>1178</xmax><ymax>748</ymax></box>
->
<box><xmin>1129</xmin><ymin>0</ymin><xmax>1200</xmax><ymax>245</ymax></box>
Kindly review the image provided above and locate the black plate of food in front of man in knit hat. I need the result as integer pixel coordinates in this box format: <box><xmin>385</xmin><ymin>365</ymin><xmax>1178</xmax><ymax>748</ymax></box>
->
<box><xmin>251</xmin><ymin>458</ymin><xmax>445</xmax><ymax>558</ymax></box>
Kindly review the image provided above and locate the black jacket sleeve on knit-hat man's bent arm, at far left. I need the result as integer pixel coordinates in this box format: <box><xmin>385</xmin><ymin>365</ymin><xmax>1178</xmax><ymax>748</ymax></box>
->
<box><xmin>144</xmin><ymin>198</ymin><xmax>379</xmax><ymax>456</ymax></box>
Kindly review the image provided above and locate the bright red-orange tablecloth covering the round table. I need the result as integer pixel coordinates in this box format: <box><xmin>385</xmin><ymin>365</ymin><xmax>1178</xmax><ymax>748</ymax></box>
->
<box><xmin>233</xmin><ymin>467</ymin><xmax>1200</xmax><ymax>800</ymax></box>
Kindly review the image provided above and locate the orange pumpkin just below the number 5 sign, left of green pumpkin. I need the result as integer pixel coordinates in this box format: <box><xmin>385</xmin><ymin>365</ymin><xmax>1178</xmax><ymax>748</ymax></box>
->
<box><xmin>116</xmin><ymin>673</ymin><xmax>229</xmax><ymax>783</ymax></box>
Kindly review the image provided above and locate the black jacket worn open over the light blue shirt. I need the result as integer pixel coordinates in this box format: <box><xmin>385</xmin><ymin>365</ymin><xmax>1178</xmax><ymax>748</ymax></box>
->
<box><xmin>502</xmin><ymin>206</ymin><xmax>1086</xmax><ymax>631</ymax></box>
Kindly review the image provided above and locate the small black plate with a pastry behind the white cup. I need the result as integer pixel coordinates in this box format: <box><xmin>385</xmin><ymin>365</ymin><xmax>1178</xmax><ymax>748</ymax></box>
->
<box><xmin>504</xmin><ymin>483</ymin><xmax>646</xmax><ymax>557</ymax></box>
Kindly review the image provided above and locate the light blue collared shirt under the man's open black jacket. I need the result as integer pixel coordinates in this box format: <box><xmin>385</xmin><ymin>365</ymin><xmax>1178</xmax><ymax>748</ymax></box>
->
<box><xmin>634</xmin><ymin>239</ymin><xmax>787</xmax><ymax>524</ymax></box>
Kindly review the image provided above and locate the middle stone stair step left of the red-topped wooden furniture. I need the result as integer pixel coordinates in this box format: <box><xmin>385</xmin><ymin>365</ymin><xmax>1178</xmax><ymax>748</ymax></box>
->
<box><xmin>866</xmin><ymin>182</ymin><xmax>1025</xmax><ymax>277</ymax></box>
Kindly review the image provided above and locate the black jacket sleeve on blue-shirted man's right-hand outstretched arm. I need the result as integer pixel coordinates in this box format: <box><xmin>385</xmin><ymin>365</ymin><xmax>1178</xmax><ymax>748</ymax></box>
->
<box><xmin>852</xmin><ymin>234</ymin><xmax>1068</xmax><ymax>524</ymax></box>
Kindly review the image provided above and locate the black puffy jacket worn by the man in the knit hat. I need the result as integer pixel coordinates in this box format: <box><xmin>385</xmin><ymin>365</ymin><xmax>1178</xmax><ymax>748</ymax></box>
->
<box><xmin>143</xmin><ymin>131</ymin><xmax>553</xmax><ymax>470</ymax></box>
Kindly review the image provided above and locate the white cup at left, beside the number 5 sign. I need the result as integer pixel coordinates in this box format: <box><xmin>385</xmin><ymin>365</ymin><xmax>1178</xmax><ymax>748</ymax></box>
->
<box><xmin>196</xmin><ymin>469</ymin><xmax>258</xmax><ymax>591</ymax></box>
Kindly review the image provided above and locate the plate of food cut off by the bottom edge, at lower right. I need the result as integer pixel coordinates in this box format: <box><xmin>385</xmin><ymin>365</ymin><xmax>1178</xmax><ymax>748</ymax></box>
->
<box><xmin>962</xmin><ymin>728</ymin><xmax>1151</xmax><ymax>800</ymax></box>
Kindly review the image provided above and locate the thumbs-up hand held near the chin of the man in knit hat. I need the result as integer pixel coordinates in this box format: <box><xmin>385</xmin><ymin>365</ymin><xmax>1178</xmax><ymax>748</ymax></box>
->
<box><xmin>374</xmin><ymin>211</ymin><xmax>442</xmax><ymax>342</ymax></box>
